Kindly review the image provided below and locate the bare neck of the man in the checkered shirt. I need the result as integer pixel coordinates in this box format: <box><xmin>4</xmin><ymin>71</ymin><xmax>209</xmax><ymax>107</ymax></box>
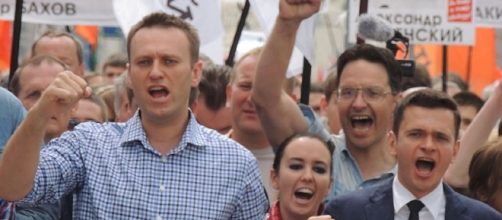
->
<box><xmin>141</xmin><ymin>110</ymin><xmax>188</xmax><ymax>155</ymax></box>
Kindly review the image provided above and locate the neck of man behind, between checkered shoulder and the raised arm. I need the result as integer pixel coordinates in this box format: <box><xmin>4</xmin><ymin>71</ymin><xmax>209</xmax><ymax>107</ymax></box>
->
<box><xmin>230</xmin><ymin>129</ymin><xmax>270</xmax><ymax>150</ymax></box>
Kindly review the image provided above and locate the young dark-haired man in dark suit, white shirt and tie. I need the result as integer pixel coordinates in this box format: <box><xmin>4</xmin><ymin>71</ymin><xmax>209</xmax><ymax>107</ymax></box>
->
<box><xmin>325</xmin><ymin>89</ymin><xmax>502</xmax><ymax>220</ymax></box>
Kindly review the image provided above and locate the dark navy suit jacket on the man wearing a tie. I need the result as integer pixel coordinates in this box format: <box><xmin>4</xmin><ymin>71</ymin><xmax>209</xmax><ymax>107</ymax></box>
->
<box><xmin>324</xmin><ymin>179</ymin><xmax>502</xmax><ymax>220</ymax></box>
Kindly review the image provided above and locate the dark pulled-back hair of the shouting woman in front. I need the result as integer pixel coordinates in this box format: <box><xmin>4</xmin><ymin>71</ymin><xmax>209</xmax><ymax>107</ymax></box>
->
<box><xmin>272</xmin><ymin>133</ymin><xmax>335</xmax><ymax>176</ymax></box>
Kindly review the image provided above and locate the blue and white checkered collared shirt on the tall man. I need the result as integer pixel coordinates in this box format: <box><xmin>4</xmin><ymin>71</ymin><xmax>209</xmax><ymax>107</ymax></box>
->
<box><xmin>21</xmin><ymin>112</ymin><xmax>268</xmax><ymax>219</ymax></box>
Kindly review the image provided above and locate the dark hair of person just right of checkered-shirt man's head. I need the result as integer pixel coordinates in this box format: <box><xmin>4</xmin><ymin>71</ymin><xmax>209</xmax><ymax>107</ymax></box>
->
<box><xmin>199</xmin><ymin>64</ymin><xmax>232</xmax><ymax>111</ymax></box>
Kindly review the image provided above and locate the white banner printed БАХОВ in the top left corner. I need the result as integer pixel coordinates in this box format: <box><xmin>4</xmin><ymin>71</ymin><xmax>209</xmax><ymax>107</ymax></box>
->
<box><xmin>0</xmin><ymin>0</ymin><xmax>118</xmax><ymax>26</ymax></box>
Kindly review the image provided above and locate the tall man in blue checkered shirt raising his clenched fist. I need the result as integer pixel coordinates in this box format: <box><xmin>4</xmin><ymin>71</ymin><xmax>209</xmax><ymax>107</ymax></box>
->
<box><xmin>0</xmin><ymin>13</ymin><xmax>268</xmax><ymax>219</ymax></box>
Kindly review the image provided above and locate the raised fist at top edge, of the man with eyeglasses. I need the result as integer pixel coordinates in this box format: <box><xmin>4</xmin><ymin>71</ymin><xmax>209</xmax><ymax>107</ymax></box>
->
<box><xmin>279</xmin><ymin>0</ymin><xmax>321</xmax><ymax>22</ymax></box>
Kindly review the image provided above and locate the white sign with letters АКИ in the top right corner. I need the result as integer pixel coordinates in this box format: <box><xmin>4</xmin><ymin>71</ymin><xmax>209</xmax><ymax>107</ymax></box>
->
<box><xmin>474</xmin><ymin>0</ymin><xmax>502</xmax><ymax>28</ymax></box>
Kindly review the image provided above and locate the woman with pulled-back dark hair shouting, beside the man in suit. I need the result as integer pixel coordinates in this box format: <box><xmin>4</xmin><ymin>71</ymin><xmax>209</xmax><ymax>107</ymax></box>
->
<box><xmin>267</xmin><ymin>134</ymin><xmax>333</xmax><ymax>220</ymax></box>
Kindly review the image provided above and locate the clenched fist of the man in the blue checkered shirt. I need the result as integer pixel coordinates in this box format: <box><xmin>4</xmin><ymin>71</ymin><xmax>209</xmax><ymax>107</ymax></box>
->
<box><xmin>33</xmin><ymin>71</ymin><xmax>92</xmax><ymax>119</ymax></box>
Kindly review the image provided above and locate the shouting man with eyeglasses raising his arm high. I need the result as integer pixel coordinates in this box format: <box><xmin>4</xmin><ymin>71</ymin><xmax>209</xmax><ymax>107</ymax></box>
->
<box><xmin>252</xmin><ymin>0</ymin><xmax>401</xmax><ymax>198</ymax></box>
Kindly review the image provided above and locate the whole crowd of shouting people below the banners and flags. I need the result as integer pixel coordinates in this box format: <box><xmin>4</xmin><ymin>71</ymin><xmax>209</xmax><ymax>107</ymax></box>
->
<box><xmin>0</xmin><ymin>0</ymin><xmax>502</xmax><ymax>220</ymax></box>
